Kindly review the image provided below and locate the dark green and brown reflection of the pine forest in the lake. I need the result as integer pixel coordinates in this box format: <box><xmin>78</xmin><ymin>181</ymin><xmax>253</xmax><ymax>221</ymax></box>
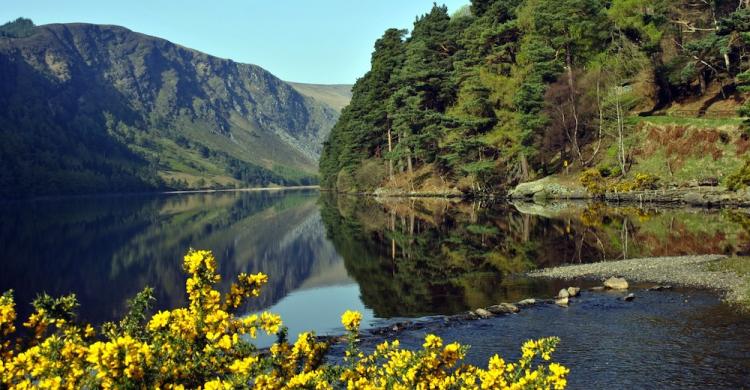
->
<box><xmin>322</xmin><ymin>196</ymin><xmax>750</xmax><ymax>318</ymax></box>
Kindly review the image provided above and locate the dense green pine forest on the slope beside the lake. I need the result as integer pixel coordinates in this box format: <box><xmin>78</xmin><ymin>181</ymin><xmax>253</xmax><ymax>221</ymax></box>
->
<box><xmin>320</xmin><ymin>0</ymin><xmax>750</xmax><ymax>193</ymax></box>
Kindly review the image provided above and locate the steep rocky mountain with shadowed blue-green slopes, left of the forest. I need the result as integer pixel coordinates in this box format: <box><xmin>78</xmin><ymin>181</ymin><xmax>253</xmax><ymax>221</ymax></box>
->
<box><xmin>0</xmin><ymin>19</ymin><xmax>342</xmax><ymax>198</ymax></box>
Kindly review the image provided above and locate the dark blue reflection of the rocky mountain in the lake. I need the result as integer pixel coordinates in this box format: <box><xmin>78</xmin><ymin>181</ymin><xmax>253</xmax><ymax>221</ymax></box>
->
<box><xmin>0</xmin><ymin>191</ymin><xmax>345</xmax><ymax>323</ymax></box>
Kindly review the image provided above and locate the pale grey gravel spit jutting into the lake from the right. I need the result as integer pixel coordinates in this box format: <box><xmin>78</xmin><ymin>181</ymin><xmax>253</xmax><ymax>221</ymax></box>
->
<box><xmin>529</xmin><ymin>255</ymin><xmax>747</xmax><ymax>302</ymax></box>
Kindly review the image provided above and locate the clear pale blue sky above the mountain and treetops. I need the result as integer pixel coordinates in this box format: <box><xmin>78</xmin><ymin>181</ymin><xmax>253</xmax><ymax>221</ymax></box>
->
<box><xmin>0</xmin><ymin>0</ymin><xmax>469</xmax><ymax>84</ymax></box>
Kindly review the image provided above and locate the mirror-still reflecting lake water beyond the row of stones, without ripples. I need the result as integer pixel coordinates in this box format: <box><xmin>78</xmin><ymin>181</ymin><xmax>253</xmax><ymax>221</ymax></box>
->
<box><xmin>0</xmin><ymin>191</ymin><xmax>750</xmax><ymax>332</ymax></box>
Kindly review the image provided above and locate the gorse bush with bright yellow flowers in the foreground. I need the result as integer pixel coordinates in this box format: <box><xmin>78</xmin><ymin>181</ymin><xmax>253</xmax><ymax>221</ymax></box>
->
<box><xmin>0</xmin><ymin>250</ymin><xmax>568</xmax><ymax>389</ymax></box>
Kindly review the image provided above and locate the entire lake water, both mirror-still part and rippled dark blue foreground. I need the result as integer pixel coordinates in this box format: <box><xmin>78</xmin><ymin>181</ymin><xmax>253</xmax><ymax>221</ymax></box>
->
<box><xmin>0</xmin><ymin>190</ymin><xmax>750</xmax><ymax>388</ymax></box>
